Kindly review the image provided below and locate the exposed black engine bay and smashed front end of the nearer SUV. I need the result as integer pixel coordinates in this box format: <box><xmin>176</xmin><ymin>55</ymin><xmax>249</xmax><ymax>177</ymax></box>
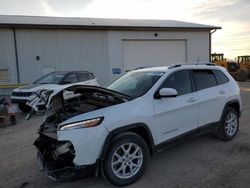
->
<box><xmin>31</xmin><ymin>86</ymin><xmax>130</xmax><ymax>181</ymax></box>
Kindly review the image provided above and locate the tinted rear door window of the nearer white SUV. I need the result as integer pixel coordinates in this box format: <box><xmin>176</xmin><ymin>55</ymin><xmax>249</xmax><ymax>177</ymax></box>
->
<box><xmin>193</xmin><ymin>70</ymin><xmax>217</xmax><ymax>90</ymax></box>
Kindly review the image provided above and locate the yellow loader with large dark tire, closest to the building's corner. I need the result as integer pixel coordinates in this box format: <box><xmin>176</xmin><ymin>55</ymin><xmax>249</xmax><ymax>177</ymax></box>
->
<box><xmin>211</xmin><ymin>53</ymin><xmax>247</xmax><ymax>81</ymax></box>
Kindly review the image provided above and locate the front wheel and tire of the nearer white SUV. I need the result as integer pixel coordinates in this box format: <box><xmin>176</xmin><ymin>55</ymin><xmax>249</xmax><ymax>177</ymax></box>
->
<box><xmin>103</xmin><ymin>132</ymin><xmax>149</xmax><ymax>186</ymax></box>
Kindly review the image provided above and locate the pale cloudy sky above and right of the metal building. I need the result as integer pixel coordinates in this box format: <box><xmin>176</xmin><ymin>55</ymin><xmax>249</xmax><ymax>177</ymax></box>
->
<box><xmin>0</xmin><ymin>0</ymin><xmax>250</xmax><ymax>59</ymax></box>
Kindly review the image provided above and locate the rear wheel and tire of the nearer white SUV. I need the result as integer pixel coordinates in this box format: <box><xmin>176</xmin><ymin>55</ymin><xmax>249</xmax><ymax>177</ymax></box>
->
<box><xmin>217</xmin><ymin>107</ymin><xmax>239</xmax><ymax>141</ymax></box>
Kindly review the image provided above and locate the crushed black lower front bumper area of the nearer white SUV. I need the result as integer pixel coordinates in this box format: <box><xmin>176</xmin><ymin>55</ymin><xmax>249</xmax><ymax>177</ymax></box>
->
<box><xmin>34</xmin><ymin>135</ymin><xmax>96</xmax><ymax>181</ymax></box>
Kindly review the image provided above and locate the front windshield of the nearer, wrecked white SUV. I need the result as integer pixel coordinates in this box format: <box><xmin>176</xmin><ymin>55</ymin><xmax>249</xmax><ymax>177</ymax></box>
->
<box><xmin>107</xmin><ymin>71</ymin><xmax>163</xmax><ymax>98</ymax></box>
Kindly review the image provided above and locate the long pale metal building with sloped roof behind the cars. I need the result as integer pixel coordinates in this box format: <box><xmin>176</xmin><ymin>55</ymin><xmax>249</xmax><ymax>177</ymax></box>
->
<box><xmin>0</xmin><ymin>16</ymin><xmax>220</xmax><ymax>84</ymax></box>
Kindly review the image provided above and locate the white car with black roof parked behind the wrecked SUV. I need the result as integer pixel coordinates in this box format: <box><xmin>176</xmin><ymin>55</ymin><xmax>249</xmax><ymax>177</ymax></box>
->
<box><xmin>11</xmin><ymin>71</ymin><xmax>99</xmax><ymax>112</ymax></box>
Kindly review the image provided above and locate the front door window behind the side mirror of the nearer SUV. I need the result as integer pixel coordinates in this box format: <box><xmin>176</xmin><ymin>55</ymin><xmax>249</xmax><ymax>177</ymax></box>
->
<box><xmin>161</xmin><ymin>70</ymin><xmax>192</xmax><ymax>96</ymax></box>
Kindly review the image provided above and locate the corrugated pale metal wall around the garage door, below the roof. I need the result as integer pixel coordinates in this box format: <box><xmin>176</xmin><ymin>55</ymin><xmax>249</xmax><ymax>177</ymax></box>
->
<box><xmin>0</xmin><ymin>28</ymin><xmax>210</xmax><ymax>84</ymax></box>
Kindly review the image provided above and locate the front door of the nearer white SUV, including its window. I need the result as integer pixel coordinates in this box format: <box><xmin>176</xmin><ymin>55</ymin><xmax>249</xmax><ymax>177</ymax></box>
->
<box><xmin>154</xmin><ymin>70</ymin><xmax>199</xmax><ymax>144</ymax></box>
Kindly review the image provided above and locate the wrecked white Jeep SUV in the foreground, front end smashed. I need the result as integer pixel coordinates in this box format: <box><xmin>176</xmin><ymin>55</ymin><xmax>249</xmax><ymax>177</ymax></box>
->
<box><xmin>34</xmin><ymin>63</ymin><xmax>242</xmax><ymax>186</ymax></box>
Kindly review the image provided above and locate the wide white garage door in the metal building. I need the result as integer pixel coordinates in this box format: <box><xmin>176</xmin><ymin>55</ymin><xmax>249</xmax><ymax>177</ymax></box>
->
<box><xmin>123</xmin><ymin>40</ymin><xmax>186</xmax><ymax>71</ymax></box>
